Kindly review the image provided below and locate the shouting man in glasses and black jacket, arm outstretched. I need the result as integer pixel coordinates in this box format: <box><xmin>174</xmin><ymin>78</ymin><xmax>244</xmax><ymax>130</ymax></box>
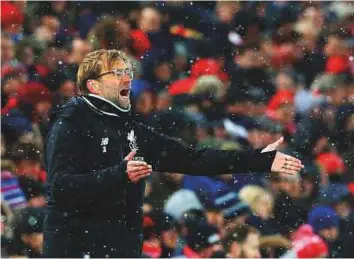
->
<box><xmin>44</xmin><ymin>50</ymin><xmax>303</xmax><ymax>257</ymax></box>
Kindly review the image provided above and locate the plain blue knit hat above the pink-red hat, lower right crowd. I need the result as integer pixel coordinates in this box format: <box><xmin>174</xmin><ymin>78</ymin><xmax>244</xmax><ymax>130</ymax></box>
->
<box><xmin>308</xmin><ymin>206</ymin><xmax>339</xmax><ymax>232</ymax></box>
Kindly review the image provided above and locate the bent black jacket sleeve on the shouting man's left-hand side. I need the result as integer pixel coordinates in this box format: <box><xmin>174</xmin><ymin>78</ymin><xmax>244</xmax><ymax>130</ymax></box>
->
<box><xmin>45</xmin><ymin>119</ymin><xmax>127</xmax><ymax>203</ymax></box>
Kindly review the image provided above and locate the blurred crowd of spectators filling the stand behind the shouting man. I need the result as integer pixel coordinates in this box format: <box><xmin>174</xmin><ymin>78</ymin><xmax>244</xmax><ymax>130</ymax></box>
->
<box><xmin>1</xmin><ymin>1</ymin><xmax>354</xmax><ymax>258</ymax></box>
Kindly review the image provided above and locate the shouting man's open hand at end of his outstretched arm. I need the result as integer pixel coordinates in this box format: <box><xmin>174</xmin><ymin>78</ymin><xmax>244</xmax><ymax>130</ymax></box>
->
<box><xmin>262</xmin><ymin>137</ymin><xmax>304</xmax><ymax>175</ymax></box>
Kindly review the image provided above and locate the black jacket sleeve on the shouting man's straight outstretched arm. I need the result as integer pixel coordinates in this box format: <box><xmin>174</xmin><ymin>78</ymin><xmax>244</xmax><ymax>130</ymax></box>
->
<box><xmin>141</xmin><ymin>125</ymin><xmax>276</xmax><ymax>175</ymax></box>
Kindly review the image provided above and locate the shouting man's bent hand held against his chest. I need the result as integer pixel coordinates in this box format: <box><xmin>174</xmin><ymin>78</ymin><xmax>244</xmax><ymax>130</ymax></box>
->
<box><xmin>124</xmin><ymin>151</ymin><xmax>152</xmax><ymax>183</ymax></box>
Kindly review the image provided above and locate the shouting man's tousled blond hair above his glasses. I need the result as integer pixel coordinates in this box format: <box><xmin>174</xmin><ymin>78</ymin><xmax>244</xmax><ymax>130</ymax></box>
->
<box><xmin>76</xmin><ymin>49</ymin><xmax>131</xmax><ymax>94</ymax></box>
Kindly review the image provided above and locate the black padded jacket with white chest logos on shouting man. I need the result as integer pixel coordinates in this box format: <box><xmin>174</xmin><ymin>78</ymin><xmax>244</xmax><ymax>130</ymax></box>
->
<box><xmin>44</xmin><ymin>95</ymin><xmax>275</xmax><ymax>257</ymax></box>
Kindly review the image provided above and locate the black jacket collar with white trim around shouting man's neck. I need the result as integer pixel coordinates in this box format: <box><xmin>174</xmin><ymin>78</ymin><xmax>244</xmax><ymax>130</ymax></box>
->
<box><xmin>82</xmin><ymin>94</ymin><xmax>131</xmax><ymax>117</ymax></box>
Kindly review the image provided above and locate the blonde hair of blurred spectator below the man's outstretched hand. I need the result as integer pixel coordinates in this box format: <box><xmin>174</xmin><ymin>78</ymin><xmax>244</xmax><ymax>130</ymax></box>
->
<box><xmin>239</xmin><ymin>185</ymin><xmax>274</xmax><ymax>212</ymax></box>
